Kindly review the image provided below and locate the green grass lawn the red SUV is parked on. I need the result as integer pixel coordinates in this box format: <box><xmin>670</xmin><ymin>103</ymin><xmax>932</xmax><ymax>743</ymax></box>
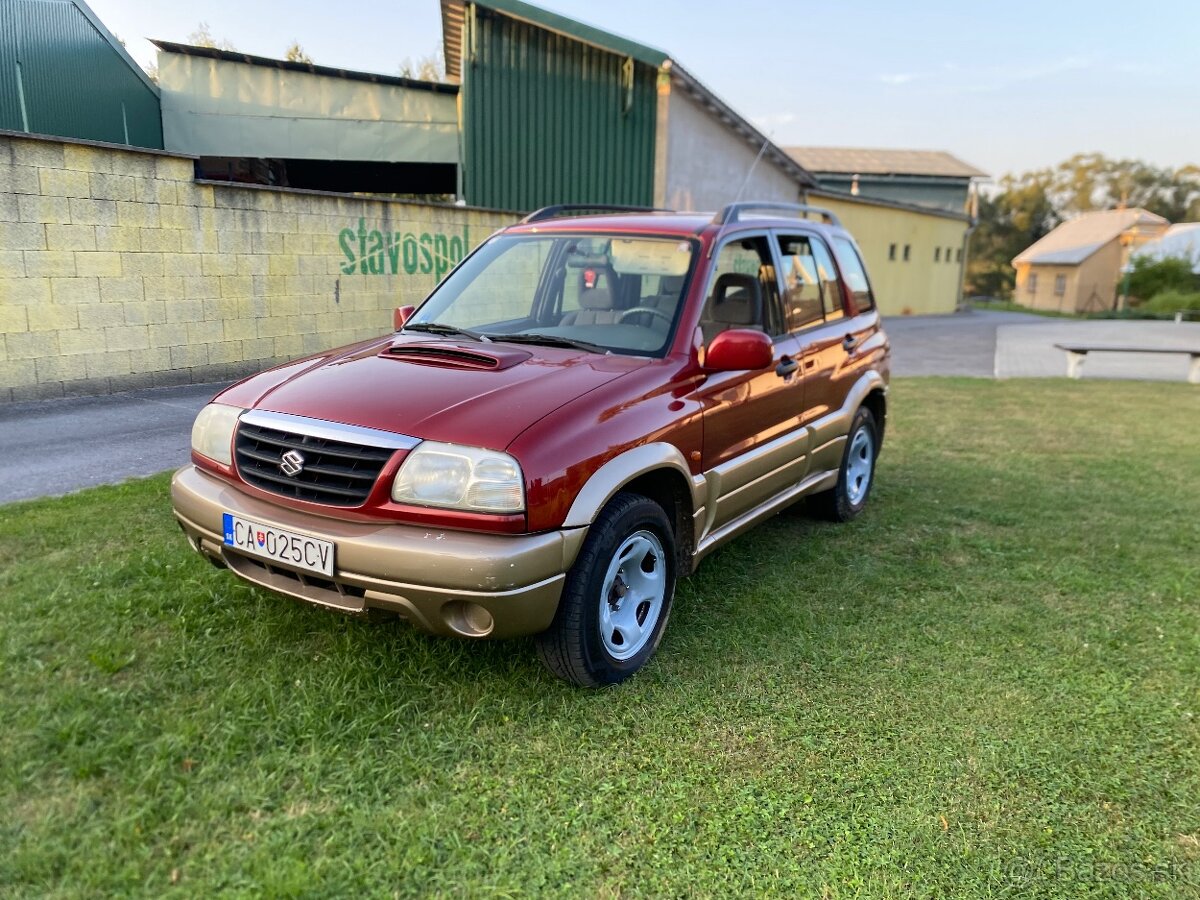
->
<box><xmin>0</xmin><ymin>379</ymin><xmax>1200</xmax><ymax>898</ymax></box>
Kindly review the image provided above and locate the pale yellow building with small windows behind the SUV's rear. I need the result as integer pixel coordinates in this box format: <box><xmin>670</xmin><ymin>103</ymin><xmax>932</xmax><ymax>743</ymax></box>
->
<box><xmin>808</xmin><ymin>191</ymin><xmax>971</xmax><ymax>316</ymax></box>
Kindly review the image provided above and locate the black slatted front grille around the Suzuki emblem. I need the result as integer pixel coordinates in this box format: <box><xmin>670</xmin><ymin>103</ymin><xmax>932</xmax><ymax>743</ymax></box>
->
<box><xmin>234</xmin><ymin>421</ymin><xmax>395</xmax><ymax>506</ymax></box>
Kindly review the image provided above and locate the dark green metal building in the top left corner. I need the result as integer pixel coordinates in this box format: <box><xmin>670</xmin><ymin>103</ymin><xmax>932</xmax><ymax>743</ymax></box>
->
<box><xmin>0</xmin><ymin>0</ymin><xmax>162</xmax><ymax>150</ymax></box>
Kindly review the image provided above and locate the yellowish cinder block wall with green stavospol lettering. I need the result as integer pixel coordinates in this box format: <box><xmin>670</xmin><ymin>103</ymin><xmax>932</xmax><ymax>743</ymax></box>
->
<box><xmin>0</xmin><ymin>133</ymin><xmax>515</xmax><ymax>401</ymax></box>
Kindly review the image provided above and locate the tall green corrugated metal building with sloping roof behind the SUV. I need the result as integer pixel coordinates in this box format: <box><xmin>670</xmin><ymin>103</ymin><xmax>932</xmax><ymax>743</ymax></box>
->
<box><xmin>442</xmin><ymin>0</ymin><xmax>815</xmax><ymax>210</ymax></box>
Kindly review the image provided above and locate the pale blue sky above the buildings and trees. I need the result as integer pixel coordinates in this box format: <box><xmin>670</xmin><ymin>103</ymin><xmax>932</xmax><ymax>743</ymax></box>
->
<box><xmin>88</xmin><ymin>0</ymin><xmax>1200</xmax><ymax>178</ymax></box>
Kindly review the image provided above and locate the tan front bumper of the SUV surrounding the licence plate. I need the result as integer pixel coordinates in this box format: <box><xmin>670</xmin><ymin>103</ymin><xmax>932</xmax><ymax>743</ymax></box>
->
<box><xmin>170</xmin><ymin>466</ymin><xmax>587</xmax><ymax>637</ymax></box>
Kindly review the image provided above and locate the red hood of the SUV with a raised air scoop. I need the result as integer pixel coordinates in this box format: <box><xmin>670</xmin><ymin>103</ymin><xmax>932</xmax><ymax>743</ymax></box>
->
<box><xmin>221</xmin><ymin>335</ymin><xmax>649</xmax><ymax>450</ymax></box>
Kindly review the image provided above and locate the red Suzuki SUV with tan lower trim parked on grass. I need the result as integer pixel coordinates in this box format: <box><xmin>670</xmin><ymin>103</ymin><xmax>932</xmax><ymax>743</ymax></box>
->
<box><xmin>172</xmin><ymin>203</ymin><xmax>889</xmax><ymax>685</ymax></box>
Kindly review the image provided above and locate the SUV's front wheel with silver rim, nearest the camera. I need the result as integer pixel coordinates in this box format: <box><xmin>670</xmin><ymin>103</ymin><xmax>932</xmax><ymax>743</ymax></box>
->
<box><xmin>536</xmin><ymin>493</ymin><xmax>676</xmax><ymax>688</ymax></box>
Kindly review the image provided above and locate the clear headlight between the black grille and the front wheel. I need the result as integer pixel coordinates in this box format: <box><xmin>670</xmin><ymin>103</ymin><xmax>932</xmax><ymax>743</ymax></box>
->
<box><xmin>391</xmin><ymin>440</ymin><xmax>524</xmax><ymax>512</ymax></box>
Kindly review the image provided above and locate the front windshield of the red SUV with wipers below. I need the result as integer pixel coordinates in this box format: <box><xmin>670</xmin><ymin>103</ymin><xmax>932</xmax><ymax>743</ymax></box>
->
<box><xmin>404</xmin><ymin>234</ymin><xmax>695</xmax><ymax>356</ymax></box>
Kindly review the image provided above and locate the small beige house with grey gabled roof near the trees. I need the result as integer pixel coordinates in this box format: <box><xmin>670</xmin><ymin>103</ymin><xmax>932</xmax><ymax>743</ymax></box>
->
<box><xmin>1013</xmin><ymin>209</ymin><xmax>1168</xmax><ymax>313</ymax></box>
